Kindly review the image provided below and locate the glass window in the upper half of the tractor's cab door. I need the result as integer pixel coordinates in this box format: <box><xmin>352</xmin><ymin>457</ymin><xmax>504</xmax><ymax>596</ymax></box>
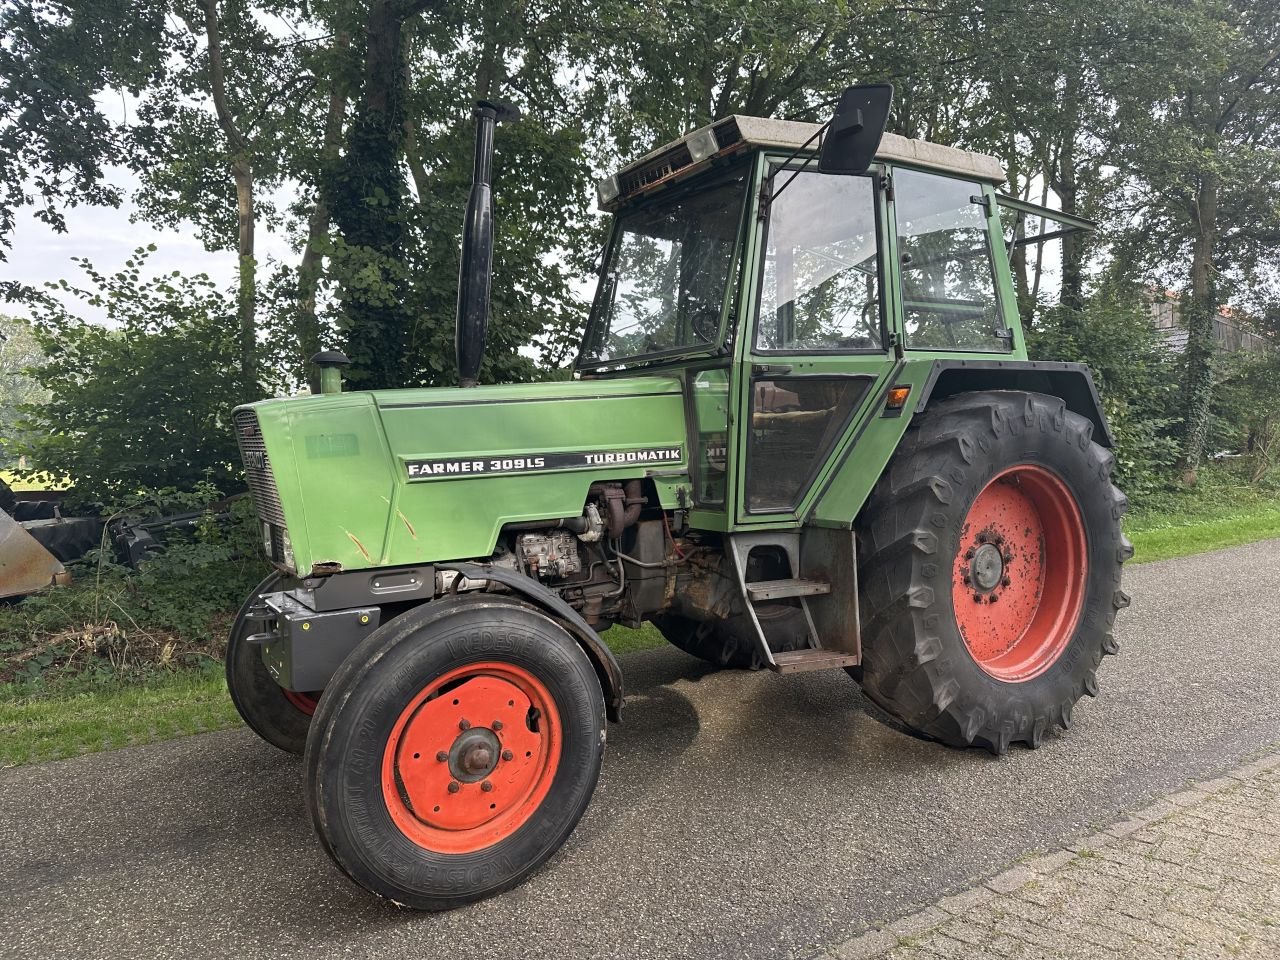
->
<box><xmin>755</xmin><ymin>169</ymin><xmax>882</xmax><ymax>352</ymax></box>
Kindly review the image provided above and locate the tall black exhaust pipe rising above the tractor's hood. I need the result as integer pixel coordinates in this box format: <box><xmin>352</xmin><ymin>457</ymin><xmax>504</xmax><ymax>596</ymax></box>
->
<box><xmin>454</xmin><ymin>100</ymin><xmax>520</xmax><ymax>387</ymax></box>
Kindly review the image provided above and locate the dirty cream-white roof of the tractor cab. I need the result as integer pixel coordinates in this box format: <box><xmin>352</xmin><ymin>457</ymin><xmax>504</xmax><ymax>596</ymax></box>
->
<box><xmin>596</xmin><ymin>114</ymin><xmax>1005</xmax><ymax>210</ymax></box>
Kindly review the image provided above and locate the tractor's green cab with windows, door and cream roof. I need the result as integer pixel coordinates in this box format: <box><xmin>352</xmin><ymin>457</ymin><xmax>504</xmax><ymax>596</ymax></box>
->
<box><xmin>576</xmin><ymin>104</ymin><xmax>1025</xmax><ymax>529</ymax></box>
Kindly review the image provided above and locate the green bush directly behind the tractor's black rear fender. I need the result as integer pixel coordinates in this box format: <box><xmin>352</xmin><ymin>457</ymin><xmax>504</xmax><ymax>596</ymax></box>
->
<box><xmin>1027</xmin><ymin>301</ymin><xmax>1179</xmax><ymax>502</ymax></box>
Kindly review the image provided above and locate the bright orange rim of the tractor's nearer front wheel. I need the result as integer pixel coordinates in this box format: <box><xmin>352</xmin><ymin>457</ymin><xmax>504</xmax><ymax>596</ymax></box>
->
<box><xmin>381</xmin><ymin>662</ymin><xmax>563</xmax><ymax>854</ymax></box>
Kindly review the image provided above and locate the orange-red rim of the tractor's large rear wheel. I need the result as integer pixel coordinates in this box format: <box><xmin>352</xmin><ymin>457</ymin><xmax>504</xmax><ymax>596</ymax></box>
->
<box><xmin>951</xmin><ymin>465</ymin><xmax>1088</xmax><ymax>684</ymax></box>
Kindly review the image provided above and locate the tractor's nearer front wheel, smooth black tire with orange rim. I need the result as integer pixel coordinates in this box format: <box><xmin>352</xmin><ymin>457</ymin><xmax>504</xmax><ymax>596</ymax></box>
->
<box><xmin>306</xmin><ymin>595</ymin><xmax>604</xmax><ymax>910</ymax></box>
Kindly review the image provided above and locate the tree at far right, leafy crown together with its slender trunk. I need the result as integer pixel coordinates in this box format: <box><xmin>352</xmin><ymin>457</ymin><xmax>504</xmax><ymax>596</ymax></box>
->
<box><xmin>1112</xmin><ymin>0</ymin><xmax>1280</xmax><ymax>484</ymax></box>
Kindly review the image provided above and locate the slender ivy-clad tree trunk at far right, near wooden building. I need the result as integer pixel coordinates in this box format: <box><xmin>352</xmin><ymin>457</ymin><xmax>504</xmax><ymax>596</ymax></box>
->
<box><xmin>1181</xmin><ymin>170</ymin><xmax>1219</xmax><ymax>486</ymax></box>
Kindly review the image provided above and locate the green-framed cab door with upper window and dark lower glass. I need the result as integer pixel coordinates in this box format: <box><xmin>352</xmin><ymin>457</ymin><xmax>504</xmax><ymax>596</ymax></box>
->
<box><xmin>733</xmin><ymin>165</ymin><xmax>901</xmax><ymax>527</ymax></box>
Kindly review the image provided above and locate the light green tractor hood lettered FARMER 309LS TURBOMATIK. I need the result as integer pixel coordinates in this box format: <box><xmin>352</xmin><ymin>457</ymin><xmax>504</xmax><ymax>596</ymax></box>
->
<box><xmin>235</xmin><ymin>376</ymin><xmax>689</xmax><ymax>573</ymax></box>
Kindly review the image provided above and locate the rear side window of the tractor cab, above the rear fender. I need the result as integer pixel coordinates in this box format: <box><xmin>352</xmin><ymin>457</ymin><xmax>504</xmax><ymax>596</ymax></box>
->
<box><xmin>893</xmin><ymin>170</ymin><xmax>1012</xmax><ymax>352</ymax></box>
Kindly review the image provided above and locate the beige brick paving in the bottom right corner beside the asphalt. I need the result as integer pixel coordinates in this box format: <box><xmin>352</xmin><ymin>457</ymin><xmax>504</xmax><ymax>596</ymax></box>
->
<box><xmin>832</xmin><ymin>754</ymin><xmax>1280</xmax><ymax>960</ymax></box>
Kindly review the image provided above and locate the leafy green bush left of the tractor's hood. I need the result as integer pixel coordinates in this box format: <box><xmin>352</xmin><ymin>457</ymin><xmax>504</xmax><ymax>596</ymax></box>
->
<box><xmin>12</xmin><ymin>250</ymin><xmax>260</xmax><ymax>502</ymax></box>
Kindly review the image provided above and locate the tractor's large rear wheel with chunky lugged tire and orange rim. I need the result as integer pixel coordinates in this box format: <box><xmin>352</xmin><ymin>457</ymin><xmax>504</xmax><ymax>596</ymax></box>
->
<box><xmin>854</xmin><ymin>390</ymin><xmax>1133</xmax><ymax>754</ymax></box>
